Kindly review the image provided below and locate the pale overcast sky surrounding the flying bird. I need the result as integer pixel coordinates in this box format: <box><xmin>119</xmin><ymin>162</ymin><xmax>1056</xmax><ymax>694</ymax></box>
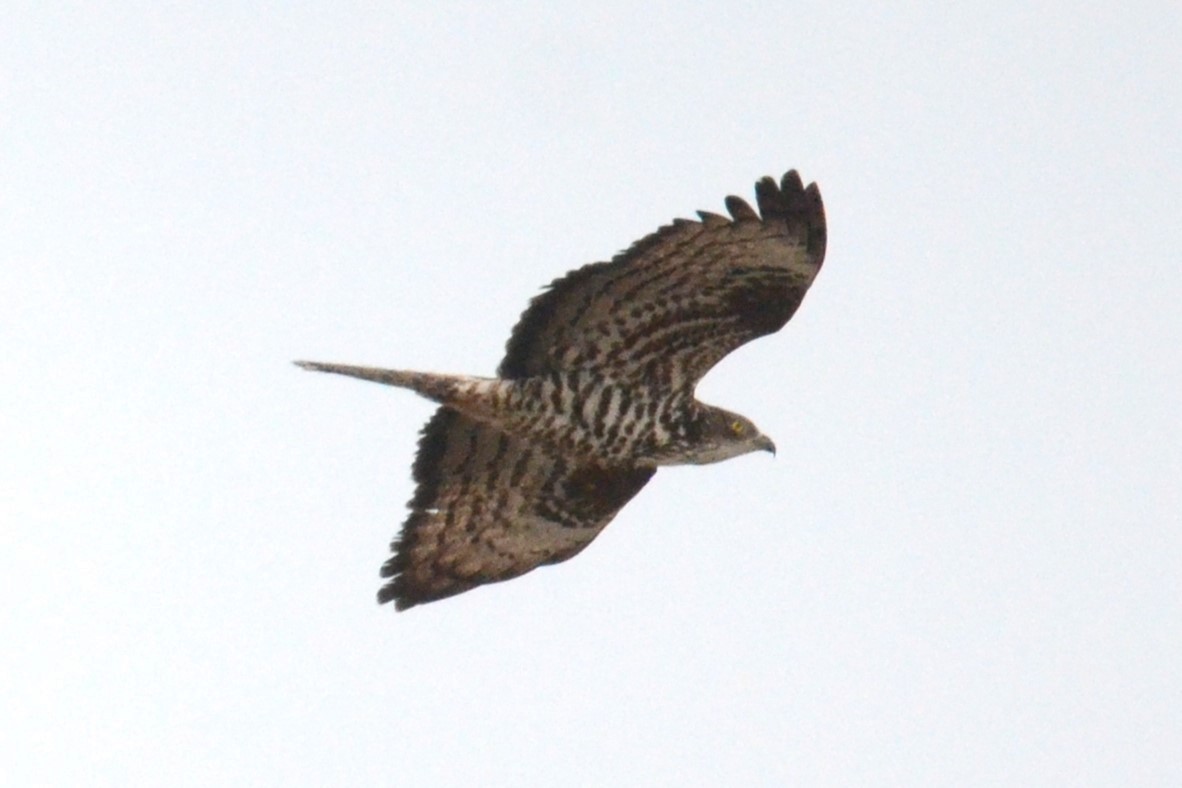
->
<box><xmin>0</xmin><ymin>1</ymin><xmax>1182</xmax><ymax>786</ymax></box>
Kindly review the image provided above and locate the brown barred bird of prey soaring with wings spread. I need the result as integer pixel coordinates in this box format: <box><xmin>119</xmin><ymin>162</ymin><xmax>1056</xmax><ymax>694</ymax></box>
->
<box><xmin>294</xmin><ymin>170</ymin><xmax>826</xmax><ymax>611</ymax></box>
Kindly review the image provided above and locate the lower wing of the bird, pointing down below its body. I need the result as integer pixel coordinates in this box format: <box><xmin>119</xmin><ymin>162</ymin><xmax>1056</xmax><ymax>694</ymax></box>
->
<box><xmin>377</xmin><ymin>408</ymin><xmax>656</xmax><ymax>610</ymax></box>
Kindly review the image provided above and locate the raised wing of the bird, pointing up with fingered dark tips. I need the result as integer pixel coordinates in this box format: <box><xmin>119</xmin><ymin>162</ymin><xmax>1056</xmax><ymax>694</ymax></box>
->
<box><xmin>499</xmin><ymin>170</ymin><xmax>825</xmax><ymax>388</ymax></box>
